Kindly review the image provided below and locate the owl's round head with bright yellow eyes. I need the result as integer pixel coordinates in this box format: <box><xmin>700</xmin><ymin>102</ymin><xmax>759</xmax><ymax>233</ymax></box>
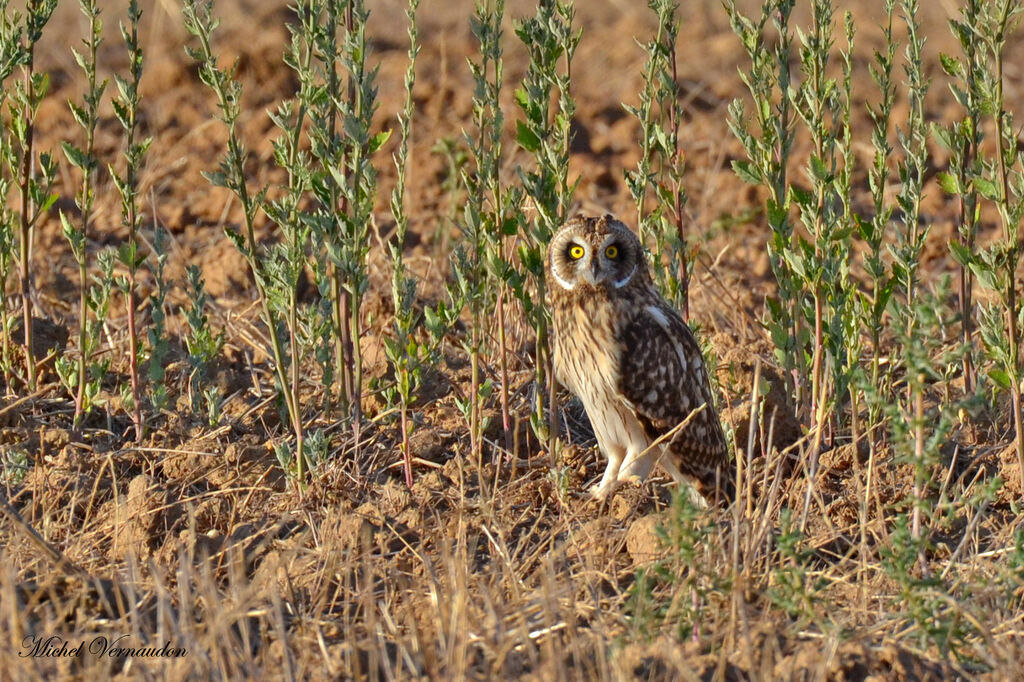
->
<box><xmin>548</xmin><ymin>215</ymin><xmax>647</xmax><ymax>291</ymax></box>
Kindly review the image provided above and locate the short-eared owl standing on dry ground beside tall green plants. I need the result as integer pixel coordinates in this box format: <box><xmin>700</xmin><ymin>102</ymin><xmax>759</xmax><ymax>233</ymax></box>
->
<box><xmin>547</xmin><ymin>215</ymin><xmax>732</xmax><ymax>500</ymax></box>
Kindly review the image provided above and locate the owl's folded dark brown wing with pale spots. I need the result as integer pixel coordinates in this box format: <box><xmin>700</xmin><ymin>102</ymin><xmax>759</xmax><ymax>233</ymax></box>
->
<box><xmin>618</xmin><ymin>303</ymin><xmax>734</xmax><ymax>499</ymax></box>
